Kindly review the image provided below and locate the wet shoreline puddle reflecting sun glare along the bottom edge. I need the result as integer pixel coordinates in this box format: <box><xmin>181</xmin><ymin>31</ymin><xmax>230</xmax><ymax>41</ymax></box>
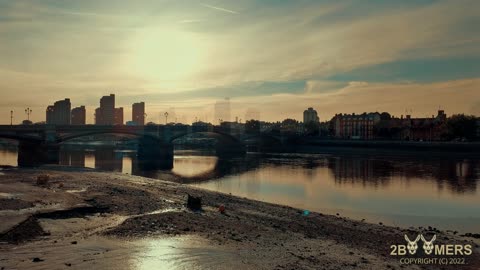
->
<box><xmin>0</xmin><ymin>236</ymin><xmax>246</xmax><ymax>270</ymax></box>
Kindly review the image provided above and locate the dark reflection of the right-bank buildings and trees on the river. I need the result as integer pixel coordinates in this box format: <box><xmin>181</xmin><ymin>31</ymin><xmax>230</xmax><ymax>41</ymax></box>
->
<box><xmin>327</xmin><ymin>156</ymin><xmax>480</xmax><ymax>193</ymax></box>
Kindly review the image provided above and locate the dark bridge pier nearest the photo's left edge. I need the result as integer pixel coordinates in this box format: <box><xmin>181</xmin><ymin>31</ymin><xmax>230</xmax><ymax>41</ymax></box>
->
<box><xmin>17</xmin><ymin>141</ymin><xmax>60</xmax><ymax>167</ymax></box>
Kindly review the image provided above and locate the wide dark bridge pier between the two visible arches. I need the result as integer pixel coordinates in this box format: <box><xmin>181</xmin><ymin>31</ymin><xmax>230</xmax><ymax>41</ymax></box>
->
<box><xmin>138</xmin><ymin>137</ymin><xmax>173</xmax><ymax>170</ymax></box>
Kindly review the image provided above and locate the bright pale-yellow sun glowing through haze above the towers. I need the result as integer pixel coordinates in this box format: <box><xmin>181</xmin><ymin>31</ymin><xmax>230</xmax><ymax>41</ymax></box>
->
<box><xmin>133</xmin><ymin>28</ymin><xmax>202</xmax><ymax>84</ymax></box>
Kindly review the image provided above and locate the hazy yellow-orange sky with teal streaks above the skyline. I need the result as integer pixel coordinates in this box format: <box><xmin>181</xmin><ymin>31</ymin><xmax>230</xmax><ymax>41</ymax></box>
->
<box><xmin>0</xmin><ymin>0</ymin><xmax>480</xmax><ymax>124</ymax></box>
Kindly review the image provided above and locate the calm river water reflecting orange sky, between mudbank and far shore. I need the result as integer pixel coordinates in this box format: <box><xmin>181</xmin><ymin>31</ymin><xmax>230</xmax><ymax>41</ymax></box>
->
<box><xmin>0</xmin><ymin>147</ymin><xmax>480</xmax><ymax>233</ymax></box>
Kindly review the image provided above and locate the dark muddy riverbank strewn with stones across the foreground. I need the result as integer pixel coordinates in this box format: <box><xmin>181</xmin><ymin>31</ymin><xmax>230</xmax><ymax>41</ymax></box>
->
<box><xmin>0</xmin><ymin>166</ymin><xmax>480</xmax><ymax>269</ymax></box>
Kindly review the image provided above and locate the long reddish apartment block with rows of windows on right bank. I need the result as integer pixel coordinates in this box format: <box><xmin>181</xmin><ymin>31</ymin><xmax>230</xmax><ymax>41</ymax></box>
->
<box><xmin>332</xmin><ymin>112</ymin><xmax>380</xmax><ymax>140</ymax></box>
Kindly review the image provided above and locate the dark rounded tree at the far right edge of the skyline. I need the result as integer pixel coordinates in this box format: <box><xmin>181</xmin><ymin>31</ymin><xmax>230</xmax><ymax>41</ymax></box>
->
<box><xmin>447</xmin><ymin>114</ymin><xmax>477</xmax><ymax>140</ymax></box>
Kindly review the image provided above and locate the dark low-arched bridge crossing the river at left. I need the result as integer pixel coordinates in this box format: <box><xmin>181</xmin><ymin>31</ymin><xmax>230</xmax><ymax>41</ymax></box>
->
<box><xmin>0</xmin><ymin>125</ymin><xmax>284</xmax><ymax>168</ymax></box>
